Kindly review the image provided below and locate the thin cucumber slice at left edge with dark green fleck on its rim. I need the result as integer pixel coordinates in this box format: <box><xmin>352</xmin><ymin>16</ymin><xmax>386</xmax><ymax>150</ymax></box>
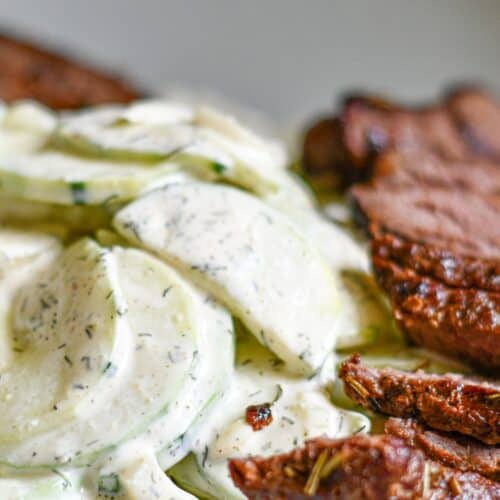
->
<box><xmin>0</xmin><ymin>152</ymin><xmax>177</xmax><ymax>205</ymax></box>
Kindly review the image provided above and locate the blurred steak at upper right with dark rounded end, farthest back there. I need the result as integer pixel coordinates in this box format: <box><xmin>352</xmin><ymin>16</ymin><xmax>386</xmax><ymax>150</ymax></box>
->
<box><xmin>303</xmin><ymin>87</ymin><xmax>500</xmax><ymax>186</ymax></box>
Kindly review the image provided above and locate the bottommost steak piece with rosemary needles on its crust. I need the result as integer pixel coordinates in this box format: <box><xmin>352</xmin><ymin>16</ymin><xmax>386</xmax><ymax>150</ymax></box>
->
<box><xmin>229</xmin><ymin>435</ymin><xmax>500</xmax><ymax>500</ymax></box>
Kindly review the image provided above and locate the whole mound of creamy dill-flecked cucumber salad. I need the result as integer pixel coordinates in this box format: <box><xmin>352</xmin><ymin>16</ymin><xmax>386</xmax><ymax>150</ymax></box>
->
<box><xmin>0</xmin><ymin>100</ymin><xmax>466</xmax><ymax>500</ymax></box>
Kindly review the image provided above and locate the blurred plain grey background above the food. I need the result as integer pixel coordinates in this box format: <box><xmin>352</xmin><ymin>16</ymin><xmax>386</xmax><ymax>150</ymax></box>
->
<box><xmin>0</xmin><ymin>0</ymin><xmax>500</xmax><ymax>121</ymax></box>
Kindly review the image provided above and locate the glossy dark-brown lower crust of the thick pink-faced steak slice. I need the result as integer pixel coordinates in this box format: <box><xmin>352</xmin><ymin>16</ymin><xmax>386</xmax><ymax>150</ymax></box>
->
<box><xmin>372</xmin><ymin>256</ymin><xmax>500</xmax><ymax>372</ymax></box>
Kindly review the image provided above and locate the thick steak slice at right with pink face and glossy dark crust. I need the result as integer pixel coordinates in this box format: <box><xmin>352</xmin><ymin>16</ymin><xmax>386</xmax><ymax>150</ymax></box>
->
<box><xmin>352</xmin><ymin>155</ymin><xmax>500</xmax><ymax>373</ymax></box>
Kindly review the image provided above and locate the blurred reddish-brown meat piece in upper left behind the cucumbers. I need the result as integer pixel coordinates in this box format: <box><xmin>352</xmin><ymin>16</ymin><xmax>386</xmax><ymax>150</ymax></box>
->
<box><xmin>0</xmin><ymin>35</ymin><xmax>141</xmax><ymax>109</ymax></box>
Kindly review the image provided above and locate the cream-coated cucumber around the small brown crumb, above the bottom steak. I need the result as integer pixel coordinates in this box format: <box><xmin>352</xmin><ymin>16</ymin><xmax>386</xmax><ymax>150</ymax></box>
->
<box><xmin>168</xmin><ymin>335</ymin><xmax>370</xmax><ymax>499</ymax></box>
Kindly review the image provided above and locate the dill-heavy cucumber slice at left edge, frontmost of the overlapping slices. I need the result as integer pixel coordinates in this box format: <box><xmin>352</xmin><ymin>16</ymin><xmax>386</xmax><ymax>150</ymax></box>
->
<box><xmin>0</xmin><ymin>240</ymin><xmax>126</xmax><ymax>447</ymax></box>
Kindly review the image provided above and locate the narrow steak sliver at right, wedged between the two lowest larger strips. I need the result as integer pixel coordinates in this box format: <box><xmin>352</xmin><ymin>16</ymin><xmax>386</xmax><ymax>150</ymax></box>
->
<box><xmin>385</xmin><ymin>418</ymin><xmax>500</xmax><ymax>481</ymax></box>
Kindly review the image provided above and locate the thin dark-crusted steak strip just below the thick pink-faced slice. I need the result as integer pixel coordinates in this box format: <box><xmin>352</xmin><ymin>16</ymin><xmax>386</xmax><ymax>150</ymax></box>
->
<box><xmin>339</xmin><ymin>355</ymin><xmax>500</xmax><ymax>445</ymax></box>
